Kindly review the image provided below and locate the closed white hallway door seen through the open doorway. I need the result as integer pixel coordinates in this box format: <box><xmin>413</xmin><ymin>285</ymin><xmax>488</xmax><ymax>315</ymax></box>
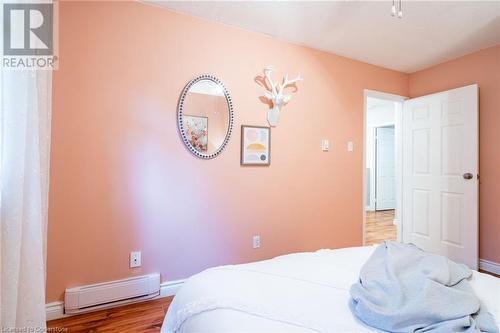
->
<box><xmin>375</xmin><ymin>126</ymin><xmax>396</xmax><ymax>210</ymax></box>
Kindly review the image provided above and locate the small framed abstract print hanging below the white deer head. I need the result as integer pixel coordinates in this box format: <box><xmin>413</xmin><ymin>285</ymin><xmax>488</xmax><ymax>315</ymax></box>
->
<box><xmin>241</xmin><ymin>125</ymin><xmax>271</xmax><ymax>165</ymax></box>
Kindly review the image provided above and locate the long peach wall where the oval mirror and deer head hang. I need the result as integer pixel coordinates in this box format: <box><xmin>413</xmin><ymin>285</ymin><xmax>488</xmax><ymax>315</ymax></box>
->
<box><xmin>47</xmin><ymin>2</ymin><xmax>408</xmax><ymax>301</ymax></box>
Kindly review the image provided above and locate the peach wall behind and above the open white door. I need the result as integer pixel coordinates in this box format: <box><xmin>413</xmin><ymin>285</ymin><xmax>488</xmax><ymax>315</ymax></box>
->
<box><xmin>410</xmin><ymin>45</ymin><xmax>500</xmax><ymax>263</ymax></box>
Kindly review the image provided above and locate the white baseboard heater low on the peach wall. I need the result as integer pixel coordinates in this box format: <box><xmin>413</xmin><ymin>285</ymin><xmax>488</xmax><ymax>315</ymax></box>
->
<box><xmin>64</xmin><ymin>274</ymin><xmax>160</xmax><ymax>314</ymax></box>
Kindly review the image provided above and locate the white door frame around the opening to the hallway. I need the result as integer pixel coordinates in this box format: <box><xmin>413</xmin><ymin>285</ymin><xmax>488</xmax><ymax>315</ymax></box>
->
<box><xmin>361</xmin><ymin>89</ymin><xmax>409</xmax><ymax>245</ymax></box>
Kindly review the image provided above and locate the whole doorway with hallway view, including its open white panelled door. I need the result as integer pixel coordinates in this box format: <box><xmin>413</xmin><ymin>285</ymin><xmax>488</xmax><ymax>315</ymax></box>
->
<box><xmin>363</xmin><ymin>84</ymin><xmax>479</xmax><ymax>269</ymax></box>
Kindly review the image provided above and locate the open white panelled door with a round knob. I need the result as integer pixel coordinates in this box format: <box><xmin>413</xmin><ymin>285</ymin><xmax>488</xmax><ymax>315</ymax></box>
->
<box><xmin>402</xmin><ymin>85</ymin><xmax>478</xmax><ymax>269</ymax></box>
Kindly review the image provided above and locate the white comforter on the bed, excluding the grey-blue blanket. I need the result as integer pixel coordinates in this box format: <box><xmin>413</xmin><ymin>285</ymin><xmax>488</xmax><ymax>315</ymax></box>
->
<box><xmin>162</xmin><ymin>247</ymin><xmax>500</xmax><ymax>333</ymax></box>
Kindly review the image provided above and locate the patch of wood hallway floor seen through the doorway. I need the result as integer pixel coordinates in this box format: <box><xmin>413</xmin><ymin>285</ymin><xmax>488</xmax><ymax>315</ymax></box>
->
<box><xmin>365</xmin><ymin>210</ymin><xmax>397</xmax><ymax>245</ymax></box>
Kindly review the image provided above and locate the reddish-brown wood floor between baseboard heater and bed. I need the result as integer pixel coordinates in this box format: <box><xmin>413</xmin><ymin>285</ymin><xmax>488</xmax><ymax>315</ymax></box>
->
<box><xmin>47</xmin><ymin>297</ymin><xmax>173</xmax><ymax>333</ymax></box>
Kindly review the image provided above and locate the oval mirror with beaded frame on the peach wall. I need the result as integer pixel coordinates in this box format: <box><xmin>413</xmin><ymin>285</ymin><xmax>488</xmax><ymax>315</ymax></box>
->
<box><xmin>177</xmin><ymin>75</ymin><xmax>233</xmax><ymax>158</ymax></box>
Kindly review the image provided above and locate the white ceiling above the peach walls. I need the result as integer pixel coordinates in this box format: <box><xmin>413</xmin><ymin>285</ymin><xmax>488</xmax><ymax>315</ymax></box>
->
<box><xmin>143</xmin><ymin>0</ymin><xmax>500</xmax><ymax>73</ymax></box>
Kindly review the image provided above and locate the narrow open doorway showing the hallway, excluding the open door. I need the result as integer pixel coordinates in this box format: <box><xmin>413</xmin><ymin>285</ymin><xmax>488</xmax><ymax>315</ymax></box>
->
<box><xmin>363</xmin><ymin>90</ymin><xmax>405</xmax><ymax>245</ymax></box>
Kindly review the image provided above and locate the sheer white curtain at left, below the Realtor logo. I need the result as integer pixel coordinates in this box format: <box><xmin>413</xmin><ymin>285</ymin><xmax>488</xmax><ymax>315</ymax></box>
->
<box><xmin>0</xmin><ymin>65</ymin><xmax>52</xmax><ymax>326</ymax></box>
